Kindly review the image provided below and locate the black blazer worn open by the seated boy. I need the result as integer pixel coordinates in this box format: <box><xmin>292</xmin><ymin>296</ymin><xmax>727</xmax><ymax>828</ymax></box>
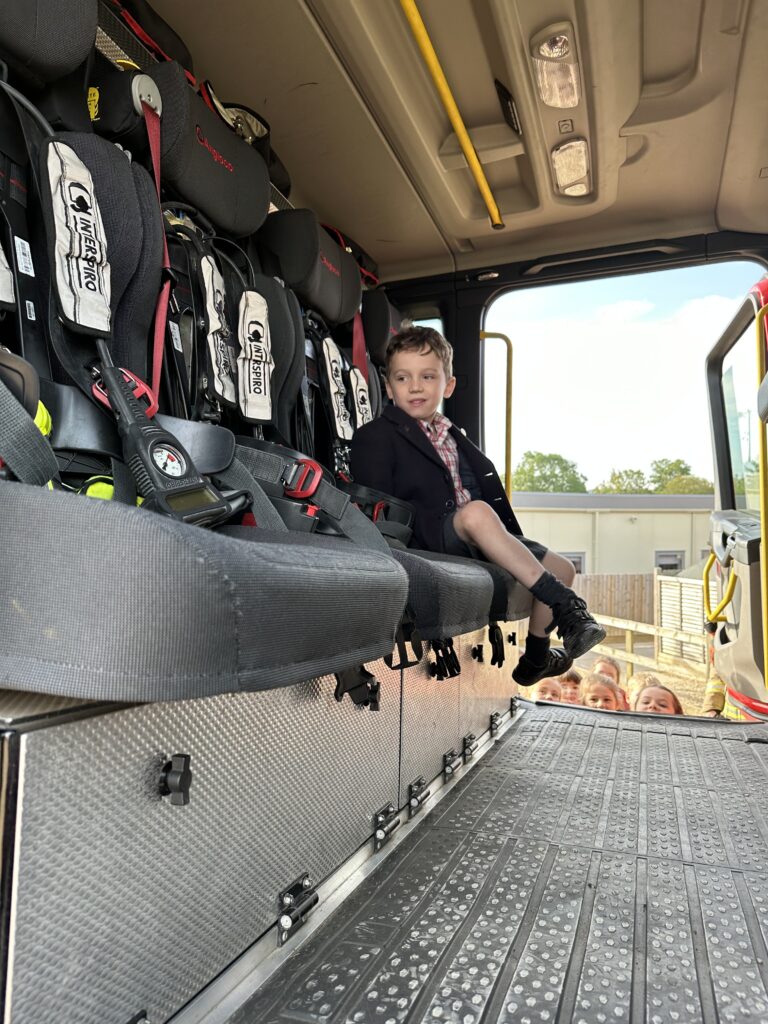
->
<box><xmin>352</xmin><ymin>406</ymin><xmax>522</xmax><ymax>551</ymax></box>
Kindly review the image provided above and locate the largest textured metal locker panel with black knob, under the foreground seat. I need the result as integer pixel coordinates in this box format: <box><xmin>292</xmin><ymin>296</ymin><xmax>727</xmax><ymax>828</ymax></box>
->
<box><xmin>6</xmin><ymin>663</ymin><xmax>400</xmax><ymax>1024</ymax></box>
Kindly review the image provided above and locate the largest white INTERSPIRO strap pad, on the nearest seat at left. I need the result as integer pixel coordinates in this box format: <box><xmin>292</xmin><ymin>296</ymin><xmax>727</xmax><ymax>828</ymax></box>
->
<box><xmin>48</xmin><ymin>141</ymin><xmax>112</xmax><ymax>335</ymax></box>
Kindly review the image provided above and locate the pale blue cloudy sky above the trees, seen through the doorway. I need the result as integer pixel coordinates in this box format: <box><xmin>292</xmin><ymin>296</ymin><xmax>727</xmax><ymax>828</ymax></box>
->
<box><xmin>485</xmin><ymin>261</ymin><xmax>763</xmax><ymax>488</ymax></box>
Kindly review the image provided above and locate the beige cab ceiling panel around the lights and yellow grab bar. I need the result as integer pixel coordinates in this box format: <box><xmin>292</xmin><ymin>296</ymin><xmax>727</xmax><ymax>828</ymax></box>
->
<box><xmin>150</xmin><ymin>0</ymin><xmax>768</xmax><ymax>279</ymax></box>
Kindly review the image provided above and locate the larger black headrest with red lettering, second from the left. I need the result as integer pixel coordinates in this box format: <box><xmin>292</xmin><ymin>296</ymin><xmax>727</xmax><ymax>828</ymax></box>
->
<box><xmin>151</xmin><ymin>61</ymin><xmax>269</xmax><ymax>238</ymax></box>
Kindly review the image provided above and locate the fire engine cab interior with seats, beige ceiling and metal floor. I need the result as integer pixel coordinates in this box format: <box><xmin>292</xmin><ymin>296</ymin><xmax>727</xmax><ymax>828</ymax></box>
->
<box><xmin>0</xmin><ymin>0</ymin><xmax>768</xmax><ymax>1024</ymax></box>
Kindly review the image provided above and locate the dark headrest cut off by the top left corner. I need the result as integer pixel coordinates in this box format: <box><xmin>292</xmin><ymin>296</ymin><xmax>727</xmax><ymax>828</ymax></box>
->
<box><xmin>0</xmin><ymin>0</ymin><xmax>98</xmax><ymax>86</ymax></box>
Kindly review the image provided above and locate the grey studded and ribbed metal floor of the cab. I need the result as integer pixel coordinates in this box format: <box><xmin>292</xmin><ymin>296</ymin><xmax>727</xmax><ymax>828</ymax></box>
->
<box><xmin>231</xmin><ymin>705</ymin><xmax>768</xmax><ymax>1024</ymax></box>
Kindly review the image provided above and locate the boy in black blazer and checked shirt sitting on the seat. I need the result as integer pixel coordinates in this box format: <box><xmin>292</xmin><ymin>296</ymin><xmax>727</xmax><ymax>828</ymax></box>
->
<box><xmin>352</xmin><ymin>325</ymin><xmax>605</xmax><ymax>686</ymax></box>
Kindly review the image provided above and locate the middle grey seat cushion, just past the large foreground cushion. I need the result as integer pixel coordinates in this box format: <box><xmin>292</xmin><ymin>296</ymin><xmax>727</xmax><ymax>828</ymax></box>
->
<box><xmin>392</xmin><ymin>549</ymin><xmax>494</xmax><ymax>640</ymax></box>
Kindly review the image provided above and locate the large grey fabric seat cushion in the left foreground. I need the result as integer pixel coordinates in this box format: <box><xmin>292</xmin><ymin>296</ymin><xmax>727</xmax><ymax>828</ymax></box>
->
<box><xmin>0</xmin><ymin>482</ymin><xmax>408</xmax><ymax>701</ymax></box>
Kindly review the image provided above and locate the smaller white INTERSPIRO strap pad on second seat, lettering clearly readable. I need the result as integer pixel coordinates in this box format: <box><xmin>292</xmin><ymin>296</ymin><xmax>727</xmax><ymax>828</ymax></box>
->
<box><xmin>238</xmin><ymin>292</ymin><xmax>274</xmax><ymax>421</ymax></box>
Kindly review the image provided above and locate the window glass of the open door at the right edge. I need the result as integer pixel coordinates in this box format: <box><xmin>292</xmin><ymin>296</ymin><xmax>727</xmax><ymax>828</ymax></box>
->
<box><xmin>723</xmin><ymin>323</ymin><xmax>761</xmax><ymax>512</ymax></box>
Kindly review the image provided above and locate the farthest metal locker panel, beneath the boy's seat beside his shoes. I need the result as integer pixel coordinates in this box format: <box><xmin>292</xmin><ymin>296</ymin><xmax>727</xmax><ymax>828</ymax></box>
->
<box><xmin>459</xmin><ymin>627</ymin><xmax>515</xmax><ymax>736</ymax></box>
